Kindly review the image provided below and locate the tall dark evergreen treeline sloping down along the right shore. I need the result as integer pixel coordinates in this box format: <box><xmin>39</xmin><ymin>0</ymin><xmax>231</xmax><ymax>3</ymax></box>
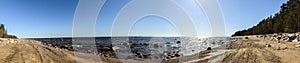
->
<box><xmin>233</xmin><ymin>0</ymin><xmax>300</xmax><ymax>36</ymax></box>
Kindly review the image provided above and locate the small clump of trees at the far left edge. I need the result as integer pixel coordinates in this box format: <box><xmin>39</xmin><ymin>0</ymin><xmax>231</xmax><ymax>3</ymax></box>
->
<box><xmin>0</xmin><ymin>24</ymin><xmax>17</xmax><ymax>38</ymax></box>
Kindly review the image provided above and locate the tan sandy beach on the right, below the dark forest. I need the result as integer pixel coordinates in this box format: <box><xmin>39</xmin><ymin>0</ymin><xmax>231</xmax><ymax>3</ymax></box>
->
<box><xmin>190</xmin><ymin>36</ymin><xmax>300</xmax><ymax>63</ymax></box>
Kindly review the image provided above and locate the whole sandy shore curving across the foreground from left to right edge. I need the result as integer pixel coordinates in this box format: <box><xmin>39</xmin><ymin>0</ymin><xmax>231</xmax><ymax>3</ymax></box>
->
<box><xmin>0</xmin><ymin>33</ymin><xmax>300</xmax><ymax>63</ymax></box>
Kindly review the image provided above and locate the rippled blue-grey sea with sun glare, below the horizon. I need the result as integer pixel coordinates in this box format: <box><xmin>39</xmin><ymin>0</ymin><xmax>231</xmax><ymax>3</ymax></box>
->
<box><xmin>31</xmin><ymin>37</ymin><xmax>233</xmax><ymax>56</ymax></box>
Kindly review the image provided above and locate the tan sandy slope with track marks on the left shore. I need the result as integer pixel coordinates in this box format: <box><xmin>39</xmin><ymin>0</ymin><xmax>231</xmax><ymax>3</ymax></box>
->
<box><xmin>0</xmin><ymin>38</ymin><xmax>101</xmax><ymax>63</ymax></box>
